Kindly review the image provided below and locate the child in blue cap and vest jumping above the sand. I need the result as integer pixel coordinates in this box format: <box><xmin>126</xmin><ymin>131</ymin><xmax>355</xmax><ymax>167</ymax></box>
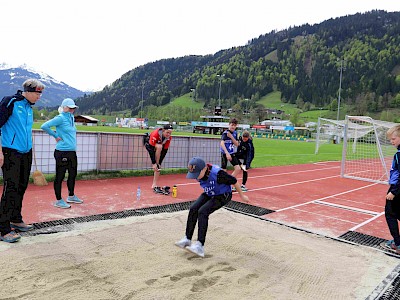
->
<box><xmin>175</xmin><ymin>157</ymin><xmax>249</xmax><ymax>257</ymax></box>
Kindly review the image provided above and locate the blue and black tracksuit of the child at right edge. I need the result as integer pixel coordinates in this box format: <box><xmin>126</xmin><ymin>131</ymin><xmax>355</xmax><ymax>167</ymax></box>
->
<box><xmin>385</xmin><ymin>148</ymin><xmax>400</xmax><ymax>246</ymax></box>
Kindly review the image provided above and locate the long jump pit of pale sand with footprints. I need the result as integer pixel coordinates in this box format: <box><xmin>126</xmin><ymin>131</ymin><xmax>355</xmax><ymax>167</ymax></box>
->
<box><xmin>0</xmin><ymin>209</ymin><xmax>399</xmax><ymax>300</ymax></box>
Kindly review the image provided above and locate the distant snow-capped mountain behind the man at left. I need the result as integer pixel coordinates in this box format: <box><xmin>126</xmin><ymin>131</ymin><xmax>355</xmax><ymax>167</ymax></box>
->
<box><xmin>0</xmin><ymin>63</ymin><xmax>88</xmax><ymax>107</ymax></box>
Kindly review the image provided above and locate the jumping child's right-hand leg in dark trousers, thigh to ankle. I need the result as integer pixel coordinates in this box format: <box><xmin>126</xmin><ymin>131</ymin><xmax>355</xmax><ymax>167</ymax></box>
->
<box><xmin>197</xmin><ymin>193</ymin><xmax>232</xmax><ymax>246</ymax></box>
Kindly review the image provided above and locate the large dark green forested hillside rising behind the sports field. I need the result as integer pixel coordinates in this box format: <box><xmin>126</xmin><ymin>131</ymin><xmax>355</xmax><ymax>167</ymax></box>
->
<box><xmin>78</xmin><ymin>11</ymin><xmax>400</xmax><ymax>120</ymax></box>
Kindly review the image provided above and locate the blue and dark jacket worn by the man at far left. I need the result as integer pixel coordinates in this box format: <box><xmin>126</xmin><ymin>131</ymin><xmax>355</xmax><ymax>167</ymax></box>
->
<box><xmin>0</xmin><ymin>91</ymin><xmax>33</xmax><ymax>153</ymax></box>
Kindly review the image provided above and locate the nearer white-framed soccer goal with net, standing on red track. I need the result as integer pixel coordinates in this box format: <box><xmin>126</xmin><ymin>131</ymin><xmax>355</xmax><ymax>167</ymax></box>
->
<box><xmin>341</xmin><ymin>116</ymin><xmax>397</xmax><ymax>184</ymax></box>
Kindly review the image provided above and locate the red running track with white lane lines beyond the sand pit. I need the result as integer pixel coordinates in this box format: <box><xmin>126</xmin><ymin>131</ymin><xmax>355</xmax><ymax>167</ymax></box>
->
<box><xmin>22</xmin><ymin>162</ymin><xmax>391</xmax><ymax>239</ymax></box>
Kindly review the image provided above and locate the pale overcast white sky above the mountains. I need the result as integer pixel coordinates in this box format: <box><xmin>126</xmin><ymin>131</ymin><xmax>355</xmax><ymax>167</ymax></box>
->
<box><xmin>0</xmin><ymin>0</ymin><xmax>400</xmax><ymax>91</ymax></box>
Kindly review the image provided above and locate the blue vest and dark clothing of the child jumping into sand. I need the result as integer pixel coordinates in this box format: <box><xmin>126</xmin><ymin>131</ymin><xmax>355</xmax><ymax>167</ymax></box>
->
<box><xmin>186</xmin><ymin>165</ymin><xmax>237</xmax><ymax>245</ymax></box>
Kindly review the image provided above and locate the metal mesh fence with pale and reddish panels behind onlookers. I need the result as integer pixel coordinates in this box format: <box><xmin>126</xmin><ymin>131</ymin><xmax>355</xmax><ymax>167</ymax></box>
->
<box><xmin>32</xmin><ymin>130</ymin><xmax>221</xmax><ymax>174</ymax></box>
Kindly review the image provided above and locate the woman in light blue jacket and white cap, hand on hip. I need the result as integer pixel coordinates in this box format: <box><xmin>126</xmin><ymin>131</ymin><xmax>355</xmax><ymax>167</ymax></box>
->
<box><xmin>41</xmin><ymin>98</ymin><xmax>83</xmax><ymax>208</ymax></box>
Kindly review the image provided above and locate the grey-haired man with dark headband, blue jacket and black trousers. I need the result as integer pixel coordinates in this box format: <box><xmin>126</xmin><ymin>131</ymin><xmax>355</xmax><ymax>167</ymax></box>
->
<box><xmin>0</xmin><ymin>79</ymin><xmax>45</xmax><ymax>243</ymax></box>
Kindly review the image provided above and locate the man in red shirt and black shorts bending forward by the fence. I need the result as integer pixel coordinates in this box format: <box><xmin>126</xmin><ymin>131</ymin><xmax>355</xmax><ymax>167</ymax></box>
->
<box><xmin>144</xmin><ymin>124</ymin><xmax>172</xmax><ymax>194</ymax></box>
